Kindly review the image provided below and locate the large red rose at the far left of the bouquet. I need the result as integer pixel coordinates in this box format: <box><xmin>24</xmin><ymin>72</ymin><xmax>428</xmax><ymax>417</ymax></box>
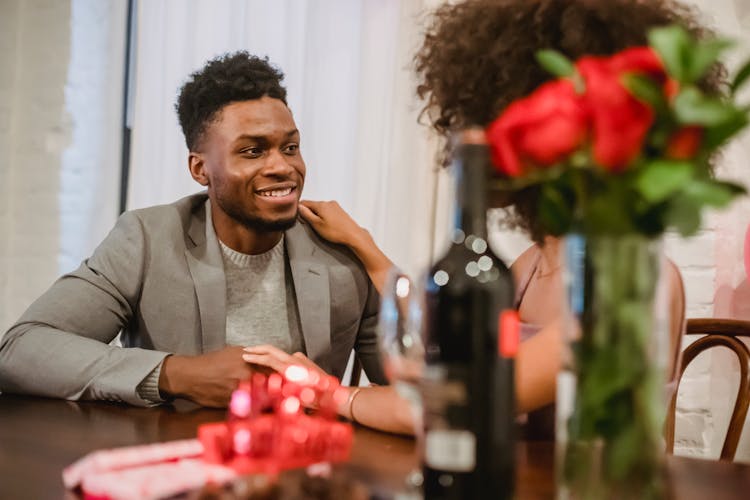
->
<box><xmin>487</xmin><ymin>80</ymin><xmax>589</xmax><ymax>177</ymax></box>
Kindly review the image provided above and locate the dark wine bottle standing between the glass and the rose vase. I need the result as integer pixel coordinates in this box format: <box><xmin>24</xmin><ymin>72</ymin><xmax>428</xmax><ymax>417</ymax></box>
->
<box><xmin>422</xmin><ymin>132</ymin><xmax>517</xmax><ymax>500</ymax></box>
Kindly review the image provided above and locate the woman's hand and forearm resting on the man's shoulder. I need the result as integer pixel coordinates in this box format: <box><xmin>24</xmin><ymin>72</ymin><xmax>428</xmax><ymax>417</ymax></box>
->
<box><xmin>299</xmin><ymin>200</ymin><xmax>393</xmax><ymax>294</ymax></box>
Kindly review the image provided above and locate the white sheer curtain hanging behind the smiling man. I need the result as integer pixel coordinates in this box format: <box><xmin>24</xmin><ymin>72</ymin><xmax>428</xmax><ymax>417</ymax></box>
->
<box><xmin>128</xmin><ymin>0</ymin><xmax>435</xmax><ymax>272</ymax></box>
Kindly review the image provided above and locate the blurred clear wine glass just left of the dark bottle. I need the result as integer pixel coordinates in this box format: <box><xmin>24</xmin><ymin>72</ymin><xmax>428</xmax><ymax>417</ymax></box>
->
<box><xmin>378</xmin><ymin>267</ymin><xmax>425</xmax><ymax>498</ymax></box>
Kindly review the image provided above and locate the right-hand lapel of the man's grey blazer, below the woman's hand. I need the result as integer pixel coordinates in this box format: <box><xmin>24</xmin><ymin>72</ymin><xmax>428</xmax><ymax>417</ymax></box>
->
<box><xmin>285</xmin><ymin>222</ymin><xmax>331</xmax><ymax>371</ymax></box>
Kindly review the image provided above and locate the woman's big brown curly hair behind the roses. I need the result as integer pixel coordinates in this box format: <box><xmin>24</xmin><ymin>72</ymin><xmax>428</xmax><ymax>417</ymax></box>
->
<box><xmin>415</xmin><ymin>0</ymin><xmax>720</xmax><ymax>242</ymax></box>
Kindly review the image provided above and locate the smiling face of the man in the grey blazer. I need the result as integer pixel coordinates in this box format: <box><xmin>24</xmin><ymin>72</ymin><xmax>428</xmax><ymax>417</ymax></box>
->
<box><xmin>190</xmin><ymin>96</ymin><xmax>305</xmax><ymax>231</ymax></box>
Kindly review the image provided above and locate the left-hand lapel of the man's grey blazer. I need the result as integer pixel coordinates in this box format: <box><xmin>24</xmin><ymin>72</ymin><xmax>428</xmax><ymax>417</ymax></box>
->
<box><xmin>185</xmin><ymin>200</ymin><xmax>227</xmax><ymax>353</ymax></box>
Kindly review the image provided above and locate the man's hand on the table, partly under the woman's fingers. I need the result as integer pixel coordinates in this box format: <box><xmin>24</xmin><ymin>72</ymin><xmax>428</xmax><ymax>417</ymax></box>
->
<box><xmin>159</xmin><ymin>346</ymin><xmax>253</xmax><ymax>408</ymax></box>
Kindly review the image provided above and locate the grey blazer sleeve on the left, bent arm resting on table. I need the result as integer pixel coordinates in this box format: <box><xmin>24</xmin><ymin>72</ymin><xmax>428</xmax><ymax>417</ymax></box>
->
<box><xmin>0</xmin><ymin>213</ymin><xmax>168</xmax><ymax>406</ymax></box>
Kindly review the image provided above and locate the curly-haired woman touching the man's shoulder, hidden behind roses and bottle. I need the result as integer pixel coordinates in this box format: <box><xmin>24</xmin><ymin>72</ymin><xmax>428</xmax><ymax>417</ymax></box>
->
<box><xmin>248</xmin><ymin>0</ymin><xmax>717</xmax><ymax>433</ymax></box>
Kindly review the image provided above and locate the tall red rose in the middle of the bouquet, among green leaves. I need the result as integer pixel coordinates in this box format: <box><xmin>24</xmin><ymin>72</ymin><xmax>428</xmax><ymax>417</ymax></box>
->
<box><xmin>576</xmin><ymin>47</ymin><xmax>667</xmax><ymax>172</ymax></box>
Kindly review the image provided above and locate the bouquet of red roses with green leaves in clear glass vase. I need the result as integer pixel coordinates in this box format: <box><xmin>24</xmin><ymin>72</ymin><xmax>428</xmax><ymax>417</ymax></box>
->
<box><xmin>487</xmin><ymin>25</ymin><xmax>750</xmax><ymax>498</ymax></box>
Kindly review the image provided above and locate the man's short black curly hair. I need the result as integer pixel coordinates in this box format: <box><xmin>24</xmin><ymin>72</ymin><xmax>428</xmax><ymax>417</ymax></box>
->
<box><xmin>175</xmin><ymin>51</ymin><xmax>286</xmax><ymax>151</ymax></box>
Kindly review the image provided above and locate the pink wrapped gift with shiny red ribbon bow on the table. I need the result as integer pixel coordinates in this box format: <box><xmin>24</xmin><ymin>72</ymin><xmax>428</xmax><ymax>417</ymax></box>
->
<box><xmin>63</xmin><ymin>365</ymin><xmax>353</xmax><ymax>500</ymax></box>
